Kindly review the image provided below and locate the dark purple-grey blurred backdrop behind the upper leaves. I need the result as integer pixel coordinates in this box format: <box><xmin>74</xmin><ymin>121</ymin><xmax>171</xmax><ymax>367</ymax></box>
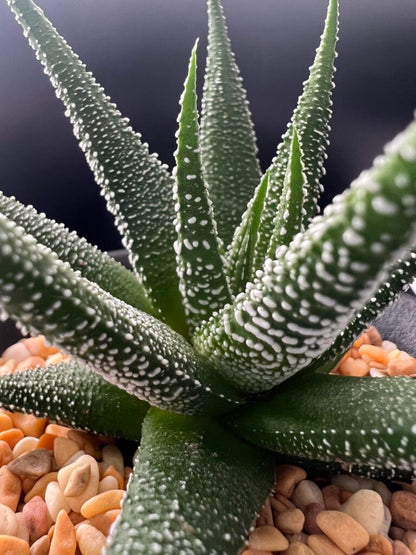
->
<box><xmin>0</xmin><ymin>0</ymin><xmax>416</xmax><ymax>249</ymax></box>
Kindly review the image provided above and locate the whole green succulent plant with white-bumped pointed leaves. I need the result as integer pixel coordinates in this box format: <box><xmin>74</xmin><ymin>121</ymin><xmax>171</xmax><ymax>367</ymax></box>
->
<box><xmin>0</xmin><ymin>0</ymin><xmax>416</xmax><ymax>554</ymax></box>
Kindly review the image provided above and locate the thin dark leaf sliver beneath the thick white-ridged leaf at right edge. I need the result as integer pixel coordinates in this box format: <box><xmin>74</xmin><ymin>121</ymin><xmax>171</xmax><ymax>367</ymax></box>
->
<box><xmin>310</xmin><ymin>249</ymin><xmax>416</xmax><ymax>372</ymax></box>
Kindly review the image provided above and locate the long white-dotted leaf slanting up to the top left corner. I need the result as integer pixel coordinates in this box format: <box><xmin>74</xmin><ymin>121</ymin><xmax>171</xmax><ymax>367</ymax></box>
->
<box><xmin>7</xmin><ymin>0</ymin><xmax>184</xmax><ymax>331</ymax></box>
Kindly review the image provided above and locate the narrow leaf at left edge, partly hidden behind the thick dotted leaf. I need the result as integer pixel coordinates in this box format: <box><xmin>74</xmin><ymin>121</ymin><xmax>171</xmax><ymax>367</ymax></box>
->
<box><xmin>0</xmin><ymin>192</ymin><xmax>155</xmax><ymax>314</ymax></box>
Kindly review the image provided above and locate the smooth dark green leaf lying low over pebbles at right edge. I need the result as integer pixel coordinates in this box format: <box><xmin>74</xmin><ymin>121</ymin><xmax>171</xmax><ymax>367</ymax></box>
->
<box><xmin>229</xmin><ymin>374</ymin><xmax>416</xmax><ymax>474</ymax></box>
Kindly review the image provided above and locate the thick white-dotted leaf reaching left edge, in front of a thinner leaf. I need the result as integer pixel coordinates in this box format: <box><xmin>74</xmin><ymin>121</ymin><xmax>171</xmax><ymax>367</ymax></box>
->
<box><xmin>0</xmin><ymin>215</ymin><xmax>244</xmax><ymax>413</ymax></box>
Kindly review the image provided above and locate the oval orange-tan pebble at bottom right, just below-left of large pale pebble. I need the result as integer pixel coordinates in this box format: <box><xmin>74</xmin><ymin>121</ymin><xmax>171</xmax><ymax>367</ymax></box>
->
<box><xmin>316</xmin><ymin>511</ymin><xmax>370</xmax><ymax>555</ymax></box>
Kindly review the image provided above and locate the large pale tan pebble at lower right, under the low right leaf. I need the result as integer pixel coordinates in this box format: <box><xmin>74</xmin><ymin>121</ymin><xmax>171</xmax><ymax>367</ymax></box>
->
<box><xmin>339</xmin><ymin>489</ymin><xmax>384</xmax><ymax>536</ymax></box>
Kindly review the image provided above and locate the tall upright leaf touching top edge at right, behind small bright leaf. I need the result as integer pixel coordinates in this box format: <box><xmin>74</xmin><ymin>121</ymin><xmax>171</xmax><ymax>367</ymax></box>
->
<box><xmin>249</xmin><ymin>0</ymin><xmax>338</xmax><ymax>274</ymax></box>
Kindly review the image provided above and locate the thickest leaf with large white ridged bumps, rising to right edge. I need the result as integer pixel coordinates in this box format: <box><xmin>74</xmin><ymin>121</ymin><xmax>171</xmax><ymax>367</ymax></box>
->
<box><xmin>194</xmin><ymin>123</ymin><xmax>416</xmax><ymax>392</ymax></box>
